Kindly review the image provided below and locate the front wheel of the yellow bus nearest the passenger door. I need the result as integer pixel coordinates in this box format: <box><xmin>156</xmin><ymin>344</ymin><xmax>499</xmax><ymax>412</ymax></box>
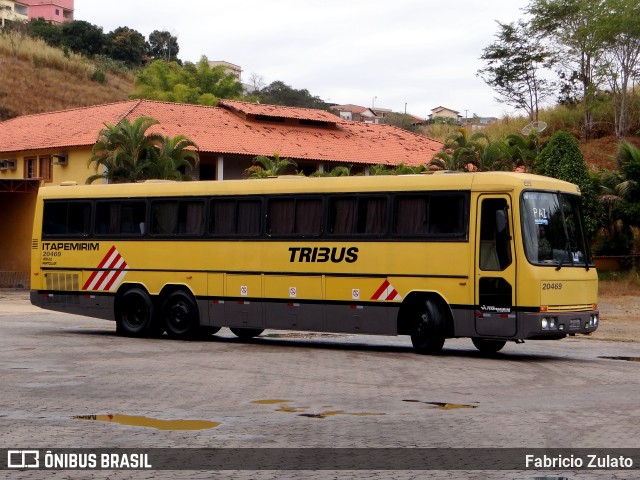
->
<box><xmin>411</xmin><ymin>299</ymin><xmax>446</xmax><ymax>355</ymax></box>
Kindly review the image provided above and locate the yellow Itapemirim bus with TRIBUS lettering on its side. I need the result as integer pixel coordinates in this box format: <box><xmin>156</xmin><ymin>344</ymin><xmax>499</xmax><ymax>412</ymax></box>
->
<box><xmin>31</xmin><ymin>172</ymin><xmax>599</xmax><ymax>354</ymax></box>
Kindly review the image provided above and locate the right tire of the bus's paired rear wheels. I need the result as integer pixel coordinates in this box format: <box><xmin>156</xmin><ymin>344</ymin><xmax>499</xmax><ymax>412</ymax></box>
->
<box><xmin>161</xmin><ymin>290</ymin><xmax>200</xmax><ymax>340</ymax></box>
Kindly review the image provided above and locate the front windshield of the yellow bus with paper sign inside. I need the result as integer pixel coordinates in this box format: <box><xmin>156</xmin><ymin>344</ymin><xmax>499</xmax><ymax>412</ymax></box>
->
<box><xmin>522</xmin><ymin>192</ymin><xmax>592</xmax><ymax>269</ymax></box>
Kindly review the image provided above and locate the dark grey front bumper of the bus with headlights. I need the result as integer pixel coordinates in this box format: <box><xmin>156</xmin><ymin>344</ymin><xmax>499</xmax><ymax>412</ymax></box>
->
<box><xmin>518</xmin><ymin>310</ymin><xmax>600</xmax><ymax>340</ymax></box>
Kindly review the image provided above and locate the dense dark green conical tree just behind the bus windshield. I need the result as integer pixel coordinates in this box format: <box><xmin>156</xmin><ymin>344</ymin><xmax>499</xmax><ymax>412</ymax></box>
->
<box><xmin>533</xmin><ymin>131</ymin><xmax>603</xmax><ymax>238</ymax></box>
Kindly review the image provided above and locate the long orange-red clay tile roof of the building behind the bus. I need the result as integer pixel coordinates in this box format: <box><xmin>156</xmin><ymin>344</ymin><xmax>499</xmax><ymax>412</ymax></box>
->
<box><xmin>0</xmin><ymin>100</ymin><xmax>443</xmax><ymax>165</ymax></box>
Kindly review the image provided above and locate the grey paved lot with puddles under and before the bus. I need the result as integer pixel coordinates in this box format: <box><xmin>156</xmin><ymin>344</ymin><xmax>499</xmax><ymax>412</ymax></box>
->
<box><xmin>0</xmin><ymin>290</ymin><xmax>640</xmax><ymax>479</ymax></box>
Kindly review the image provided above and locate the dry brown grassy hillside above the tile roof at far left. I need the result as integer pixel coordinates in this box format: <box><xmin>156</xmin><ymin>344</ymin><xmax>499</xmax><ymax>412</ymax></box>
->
<box><xmin>0</xmin><ymin>50</ymin><xmax>134</xmax><ymax>120</ymax></box>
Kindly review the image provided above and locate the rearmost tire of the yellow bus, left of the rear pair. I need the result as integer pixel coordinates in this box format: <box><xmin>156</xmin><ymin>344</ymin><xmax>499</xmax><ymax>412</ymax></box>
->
<box><xmin>116</xmin><ymin>288</ymin><xmax>155</xmax><ymax>337</ymax></box>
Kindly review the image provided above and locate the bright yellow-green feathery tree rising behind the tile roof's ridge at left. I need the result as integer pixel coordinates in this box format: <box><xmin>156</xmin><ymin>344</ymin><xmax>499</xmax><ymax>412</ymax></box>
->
<box><xmin>132</xmin><ymin>56</ymin><xmax>242</xmax><ymax>105</ymax></box>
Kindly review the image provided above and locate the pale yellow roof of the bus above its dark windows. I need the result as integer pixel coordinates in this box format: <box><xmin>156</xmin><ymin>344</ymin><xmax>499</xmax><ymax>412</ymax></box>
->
<box><xmin>39</xmin><ymin>172</ymin><xmax>580</xmax><ymax>198</ymax></box>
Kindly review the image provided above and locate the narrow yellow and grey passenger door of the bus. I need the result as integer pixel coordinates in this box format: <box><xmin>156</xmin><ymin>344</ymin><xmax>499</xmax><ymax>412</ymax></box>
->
<box><xmin>475</xmin><ymin>195</ymin><xmax>517</xmax><ymax>337</ymax></box>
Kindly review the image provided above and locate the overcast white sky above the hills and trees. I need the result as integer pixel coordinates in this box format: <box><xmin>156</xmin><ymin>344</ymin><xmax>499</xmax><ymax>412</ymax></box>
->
<box><xmin>74</xmin><ymin>0</ymin><xmax>528</xmax><ymax>118</ymax></box>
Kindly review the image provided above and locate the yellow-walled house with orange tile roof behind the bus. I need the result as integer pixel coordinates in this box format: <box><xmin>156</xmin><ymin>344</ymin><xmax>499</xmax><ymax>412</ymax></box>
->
<box><xmin>0</xmin><ymin>100</ymin><xmax>443</xmax><ymax>288</ymax></box>
